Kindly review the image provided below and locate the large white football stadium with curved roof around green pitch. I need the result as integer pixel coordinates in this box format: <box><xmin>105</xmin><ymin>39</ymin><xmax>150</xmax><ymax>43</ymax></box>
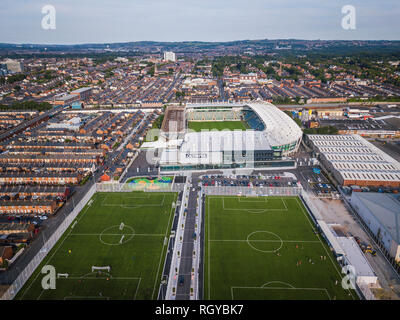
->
<box><xmin>142</xmin><ymin>102</ymin><xmax>302</xmax><ymax>171</ymax></box>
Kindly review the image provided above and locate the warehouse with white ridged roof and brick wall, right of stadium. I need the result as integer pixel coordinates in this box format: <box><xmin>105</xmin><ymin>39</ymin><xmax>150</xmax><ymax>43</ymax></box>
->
<box><xmin>307</xmin><ymin>134</ymin><xmax>400</xmax><ymax>187</ymax></box>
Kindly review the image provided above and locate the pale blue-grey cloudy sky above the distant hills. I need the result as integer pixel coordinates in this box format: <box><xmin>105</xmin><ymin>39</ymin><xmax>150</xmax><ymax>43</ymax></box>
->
<box><xmin>0</xmin><ymin>0</ymin><xmax>400</xmax><ymax>44</ymax></box>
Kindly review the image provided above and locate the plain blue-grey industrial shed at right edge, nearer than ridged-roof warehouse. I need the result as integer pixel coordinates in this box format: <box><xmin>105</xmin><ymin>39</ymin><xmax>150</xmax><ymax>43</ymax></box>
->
<box><xmin>351</xmin><ymin>192</ymin><xmax>400</xmax><ymax>261</ymax></box>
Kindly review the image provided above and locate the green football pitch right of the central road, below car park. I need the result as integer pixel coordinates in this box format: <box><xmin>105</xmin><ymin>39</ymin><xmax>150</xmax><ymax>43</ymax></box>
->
<box><xmin>204</xmin><ymin>196</ymin><xmax>358</xmax><ymax>300</ymax></box>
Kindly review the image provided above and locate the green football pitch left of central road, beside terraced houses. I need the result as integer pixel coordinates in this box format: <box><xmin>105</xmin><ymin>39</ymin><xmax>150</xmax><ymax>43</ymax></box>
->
<box><xmin>16</xmin><ymin>192</ymin><xmax>177</xmax><ymax>300</ymax></box>
